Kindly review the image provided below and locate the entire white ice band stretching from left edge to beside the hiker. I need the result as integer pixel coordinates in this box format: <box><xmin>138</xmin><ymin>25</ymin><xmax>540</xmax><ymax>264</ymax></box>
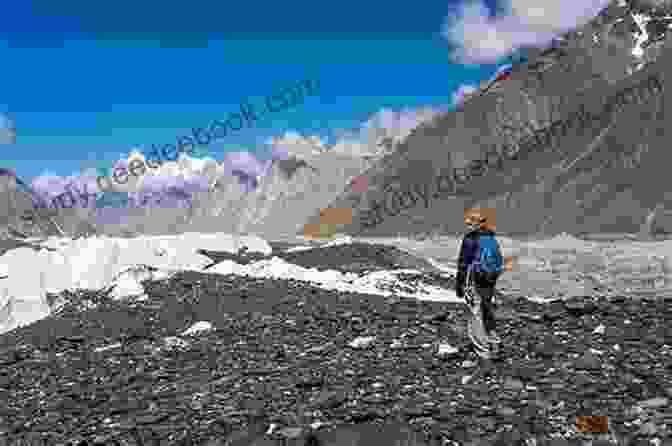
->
<box><xmin>0</xmin><ymin>233</ymin><xmax>457</xmax><ymax>333</ymax></box>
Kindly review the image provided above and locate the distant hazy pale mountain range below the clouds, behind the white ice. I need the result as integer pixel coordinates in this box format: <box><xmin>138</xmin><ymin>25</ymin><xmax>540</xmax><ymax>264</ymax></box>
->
<box><xmin>0</xmin><ymin>151</ymin><xmax>378</xmax><ymax>239</ymax></box>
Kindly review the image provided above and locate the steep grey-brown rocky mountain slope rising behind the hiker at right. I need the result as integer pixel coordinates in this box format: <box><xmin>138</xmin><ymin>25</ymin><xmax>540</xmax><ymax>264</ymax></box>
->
<box><xmin>309</xmin><ymin>0</ymin><xmax>672</xmax><ymax>240</ymax></box>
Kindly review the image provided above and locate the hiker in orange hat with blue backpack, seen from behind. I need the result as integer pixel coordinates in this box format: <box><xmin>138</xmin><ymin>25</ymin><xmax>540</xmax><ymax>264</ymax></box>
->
<box><xmin>455</xmin><ymin>209</ymin><xmax>504</xmax><ymax>359</ymax></box>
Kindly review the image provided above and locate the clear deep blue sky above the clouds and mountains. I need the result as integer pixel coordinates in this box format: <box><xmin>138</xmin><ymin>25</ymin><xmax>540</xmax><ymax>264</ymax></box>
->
<box><xmin>0</xmin><ymin>0</ymin><xmax>516</xmax><ymax>179</ymax></box>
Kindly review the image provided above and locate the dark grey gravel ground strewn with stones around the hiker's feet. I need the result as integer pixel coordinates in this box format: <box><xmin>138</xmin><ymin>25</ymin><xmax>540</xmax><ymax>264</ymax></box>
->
<box><xmin>0</xmin><ymin>245</ymin><xmax>672</xmax><ymax>446</ymax></box>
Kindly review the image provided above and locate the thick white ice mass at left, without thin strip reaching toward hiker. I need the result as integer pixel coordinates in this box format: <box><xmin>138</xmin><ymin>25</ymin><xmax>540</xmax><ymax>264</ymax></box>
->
<box><xmin>0</xmin><ymin>233</ymin><xmax>271</xmax><ymax>333</ymax></box>
